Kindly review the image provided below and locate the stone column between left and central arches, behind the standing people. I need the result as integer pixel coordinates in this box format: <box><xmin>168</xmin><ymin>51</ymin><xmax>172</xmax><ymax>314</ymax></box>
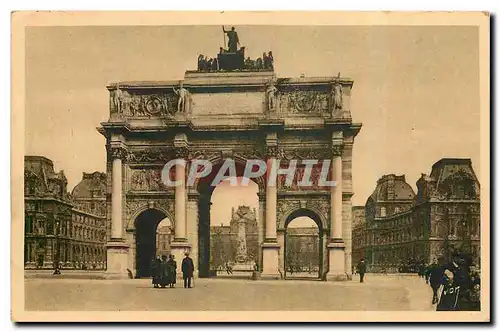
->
<box><xmin>170</xmin><ymin>134</ymin><xmax>191</xmax><ymax>262</ymax></box>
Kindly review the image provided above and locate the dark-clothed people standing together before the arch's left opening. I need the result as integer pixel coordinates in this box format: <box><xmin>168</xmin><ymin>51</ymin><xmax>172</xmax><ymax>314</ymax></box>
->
<box><xmin>151</xmin><ymin>252</ymin><xmax>194</xmax><ymax>288</ymax></box>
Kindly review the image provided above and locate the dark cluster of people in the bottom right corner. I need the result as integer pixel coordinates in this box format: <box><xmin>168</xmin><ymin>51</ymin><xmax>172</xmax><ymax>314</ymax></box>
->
<box><xmin>419</xmin><ymin>254</ymin><xmax>481</xmax><ymax>311</ymax></box>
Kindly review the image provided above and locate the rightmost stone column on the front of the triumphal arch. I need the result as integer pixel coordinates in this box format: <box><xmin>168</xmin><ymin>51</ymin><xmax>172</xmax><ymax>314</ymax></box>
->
<box><xmin>326</xmin><ymin>144</ymin><xmax>347</xmax><ymax>280</ymax></box>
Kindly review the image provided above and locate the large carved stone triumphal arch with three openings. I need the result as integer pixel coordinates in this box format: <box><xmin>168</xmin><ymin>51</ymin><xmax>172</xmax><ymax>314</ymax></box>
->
<box><xmin>99</xmin><ymin>43</ymin><xmax>361</xmax><ymax>280</ymax></box>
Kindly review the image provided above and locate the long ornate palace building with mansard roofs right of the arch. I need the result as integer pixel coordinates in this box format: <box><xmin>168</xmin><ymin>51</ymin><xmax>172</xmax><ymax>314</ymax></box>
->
<box><xmin>352</xmin><ymin>158</ymin><xmax>480</xmax><ymax>272</ymax></box>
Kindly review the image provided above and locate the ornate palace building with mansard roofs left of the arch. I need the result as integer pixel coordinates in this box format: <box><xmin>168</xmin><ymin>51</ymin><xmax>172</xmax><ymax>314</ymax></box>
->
<box><xmin>24</xmin><ymin>156</ymin><xmax>106</xmax><ymax>269</ymax></box>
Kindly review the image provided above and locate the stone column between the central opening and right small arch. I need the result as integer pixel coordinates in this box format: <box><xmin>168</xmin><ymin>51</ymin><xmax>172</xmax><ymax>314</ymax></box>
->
<box><xmin>261</xmin><ymin>141</ymin><xmax>281</xmax><ymax>279</ymax></box>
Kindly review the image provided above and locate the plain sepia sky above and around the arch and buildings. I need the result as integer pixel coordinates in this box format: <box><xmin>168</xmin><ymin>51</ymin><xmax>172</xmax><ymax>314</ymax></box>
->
<box><xmin>25</xmin><ymin>26</ymin><xmax>480</xmax><ymax>227</ymax></box>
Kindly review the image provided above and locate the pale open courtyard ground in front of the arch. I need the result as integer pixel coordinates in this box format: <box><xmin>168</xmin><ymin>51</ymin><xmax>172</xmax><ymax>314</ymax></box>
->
<box><xmin>25</xmin><ymin>275</ymin><xmax>434</xmax><ymax>311</ymax></box>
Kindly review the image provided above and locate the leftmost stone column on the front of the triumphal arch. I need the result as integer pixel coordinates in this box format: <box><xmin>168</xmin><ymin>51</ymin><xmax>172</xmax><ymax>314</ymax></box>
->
<box><xmin>106</xmin><ymin>147</ymin><xmax>129</xmax><ymax>279</ymax></box>
